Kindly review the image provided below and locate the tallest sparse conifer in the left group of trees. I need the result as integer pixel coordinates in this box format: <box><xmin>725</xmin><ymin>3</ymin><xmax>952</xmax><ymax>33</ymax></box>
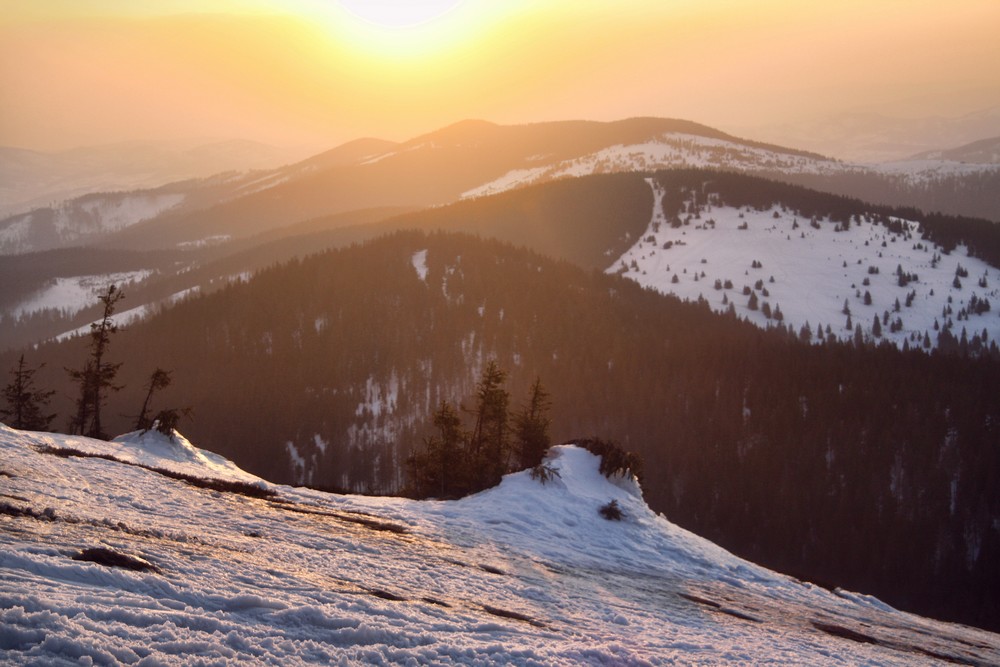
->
<box><xmin>66</xmin><ymin>284</ymin><xmax>125</xmax><ymax>440</ymax></box>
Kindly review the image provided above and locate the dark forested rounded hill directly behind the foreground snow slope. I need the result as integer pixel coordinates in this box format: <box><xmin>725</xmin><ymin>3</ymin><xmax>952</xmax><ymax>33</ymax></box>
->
<box><xmin>7</xmin><ymin>232</ymin><xmax>1000</xmax><ymax>627</ymax></box>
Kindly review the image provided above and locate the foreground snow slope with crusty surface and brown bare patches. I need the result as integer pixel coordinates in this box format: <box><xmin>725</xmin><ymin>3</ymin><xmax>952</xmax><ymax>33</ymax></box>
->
<box><xmin>0</xmin><ymin>427</ymin><xmax>1000</xmax><ymax>665</ymax></box>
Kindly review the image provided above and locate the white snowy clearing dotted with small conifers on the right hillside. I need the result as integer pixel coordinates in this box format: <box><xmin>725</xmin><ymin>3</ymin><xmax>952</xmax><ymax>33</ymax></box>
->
<box><xmin>608</xmin><ymin>179</ymin><xmax>1000</xmax><ymax>354</ymax></box>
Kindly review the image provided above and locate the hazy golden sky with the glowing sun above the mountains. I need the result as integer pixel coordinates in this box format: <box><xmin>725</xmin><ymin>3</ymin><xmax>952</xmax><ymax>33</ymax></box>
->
<box><xmin>0</xmin><ymin>0</ymin><xmax>1000</xmax><ymax>149</ymax></box>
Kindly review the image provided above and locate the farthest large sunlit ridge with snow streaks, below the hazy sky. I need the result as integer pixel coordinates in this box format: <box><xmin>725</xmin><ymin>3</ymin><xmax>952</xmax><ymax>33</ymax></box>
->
<box><xmin>9</xmin><ymin>118</ymin><xmax>1000</xmax><ymax>254</ymax></box>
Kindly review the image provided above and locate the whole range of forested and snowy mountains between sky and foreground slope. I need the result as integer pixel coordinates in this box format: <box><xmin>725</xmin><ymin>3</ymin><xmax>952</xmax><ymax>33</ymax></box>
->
<box><xmin>0</xmin><ymin>119</ymin><xmax>1000</xmax><ymax>628</ymax></box>
